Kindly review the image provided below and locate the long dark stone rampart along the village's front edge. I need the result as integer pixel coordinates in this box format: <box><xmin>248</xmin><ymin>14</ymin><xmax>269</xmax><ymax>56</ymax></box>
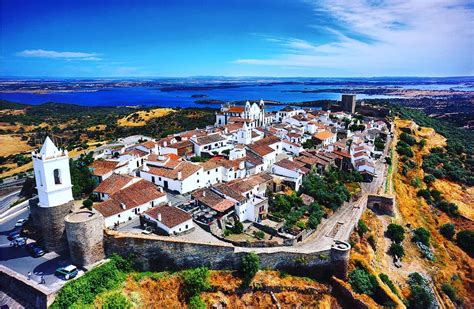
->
<box><xmin>104</xmin><ymin>231</ymin><xmax>350</xmax><ymax>278</ymax></box>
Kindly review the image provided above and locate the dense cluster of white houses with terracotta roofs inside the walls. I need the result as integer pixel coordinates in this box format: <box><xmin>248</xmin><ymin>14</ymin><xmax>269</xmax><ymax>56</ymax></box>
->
<box><xmin>89</xmin><ymin>96</ymin><xmax>390</xmax><ymax>236</ymax></box>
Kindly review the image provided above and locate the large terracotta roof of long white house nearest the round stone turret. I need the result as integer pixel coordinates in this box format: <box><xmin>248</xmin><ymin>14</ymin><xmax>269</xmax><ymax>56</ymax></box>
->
<box><xmin>94</xmin><ymin>180</ymin><xmax>166</xmax><ymax>217</ymax></box>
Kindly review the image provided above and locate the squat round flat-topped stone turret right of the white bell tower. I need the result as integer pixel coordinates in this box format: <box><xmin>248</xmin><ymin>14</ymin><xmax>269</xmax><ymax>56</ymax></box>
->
<box><xmin>65</xmin><ymin>211</ymin><xmax>105</xmax><ymax>267</ymax></box>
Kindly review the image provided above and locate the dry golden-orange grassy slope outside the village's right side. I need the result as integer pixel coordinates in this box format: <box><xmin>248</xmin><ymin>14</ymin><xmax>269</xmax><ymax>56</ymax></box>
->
<box><xmin>351</xmin><ymin>116</ymin><xmax>474</xmax><ymax>307</ymax></box>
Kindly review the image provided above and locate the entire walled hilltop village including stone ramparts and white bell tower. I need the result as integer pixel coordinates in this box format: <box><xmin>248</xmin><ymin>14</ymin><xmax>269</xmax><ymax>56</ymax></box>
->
<box><xmin>1</xmin><ymin>95</ymin><xmax>393</xmax><ymax>307</ymax></box>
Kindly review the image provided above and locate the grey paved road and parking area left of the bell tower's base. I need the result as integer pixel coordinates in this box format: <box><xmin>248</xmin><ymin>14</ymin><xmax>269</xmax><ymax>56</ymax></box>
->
<box><xmin>0</xmin><ymin>209</ymin><xmax>70</xmax><ymax>290</ymax></box>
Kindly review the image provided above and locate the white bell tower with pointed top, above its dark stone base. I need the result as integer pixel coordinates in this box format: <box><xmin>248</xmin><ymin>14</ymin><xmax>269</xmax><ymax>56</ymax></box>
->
<box><xmin>33</xmin><ymin>137</ymin><xmax>73</xmax><ymax>207</ymax></box>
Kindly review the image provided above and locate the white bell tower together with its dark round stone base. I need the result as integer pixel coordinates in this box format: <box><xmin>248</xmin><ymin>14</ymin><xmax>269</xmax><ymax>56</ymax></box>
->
<box><xmin>30</xmin><ymin>137</ymin><xmax>73</xmax><ymax>252</ymax></box>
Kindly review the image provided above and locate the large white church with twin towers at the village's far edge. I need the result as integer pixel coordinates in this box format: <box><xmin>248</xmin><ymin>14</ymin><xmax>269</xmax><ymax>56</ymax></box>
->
<box><xmin>215</xmin><ymin>100</ymin><xmax>272</xmax><ymax>128</ymax></box>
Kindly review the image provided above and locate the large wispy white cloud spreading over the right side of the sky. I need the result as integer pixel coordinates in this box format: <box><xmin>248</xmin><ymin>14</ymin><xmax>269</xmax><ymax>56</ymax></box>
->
<box><xmin>235</xmin><ymin>0</ymin><xmax>474</xmax><ymax>75</ymax></box>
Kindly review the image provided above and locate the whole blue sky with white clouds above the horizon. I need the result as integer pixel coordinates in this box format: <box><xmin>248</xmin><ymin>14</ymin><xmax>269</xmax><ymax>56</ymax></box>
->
<box><xmin>0</xmin><ymin>0</ymin><xmax>474</xmax><ymax>77</ymax></box>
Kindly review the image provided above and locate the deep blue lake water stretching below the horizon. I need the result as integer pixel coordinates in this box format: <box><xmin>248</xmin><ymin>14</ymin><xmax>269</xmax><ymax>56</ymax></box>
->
<box><xmin>0</xmin><ymin>80</ymin><xmax>466</xmax><ymax>109</ymax></box>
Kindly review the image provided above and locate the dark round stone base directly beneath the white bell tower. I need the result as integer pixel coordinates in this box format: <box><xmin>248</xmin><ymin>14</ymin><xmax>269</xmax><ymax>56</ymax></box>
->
<box><xmin>30</xmin><ymin>199</ymin><xmax>73</xmax><ymax>252</ymax></box>
